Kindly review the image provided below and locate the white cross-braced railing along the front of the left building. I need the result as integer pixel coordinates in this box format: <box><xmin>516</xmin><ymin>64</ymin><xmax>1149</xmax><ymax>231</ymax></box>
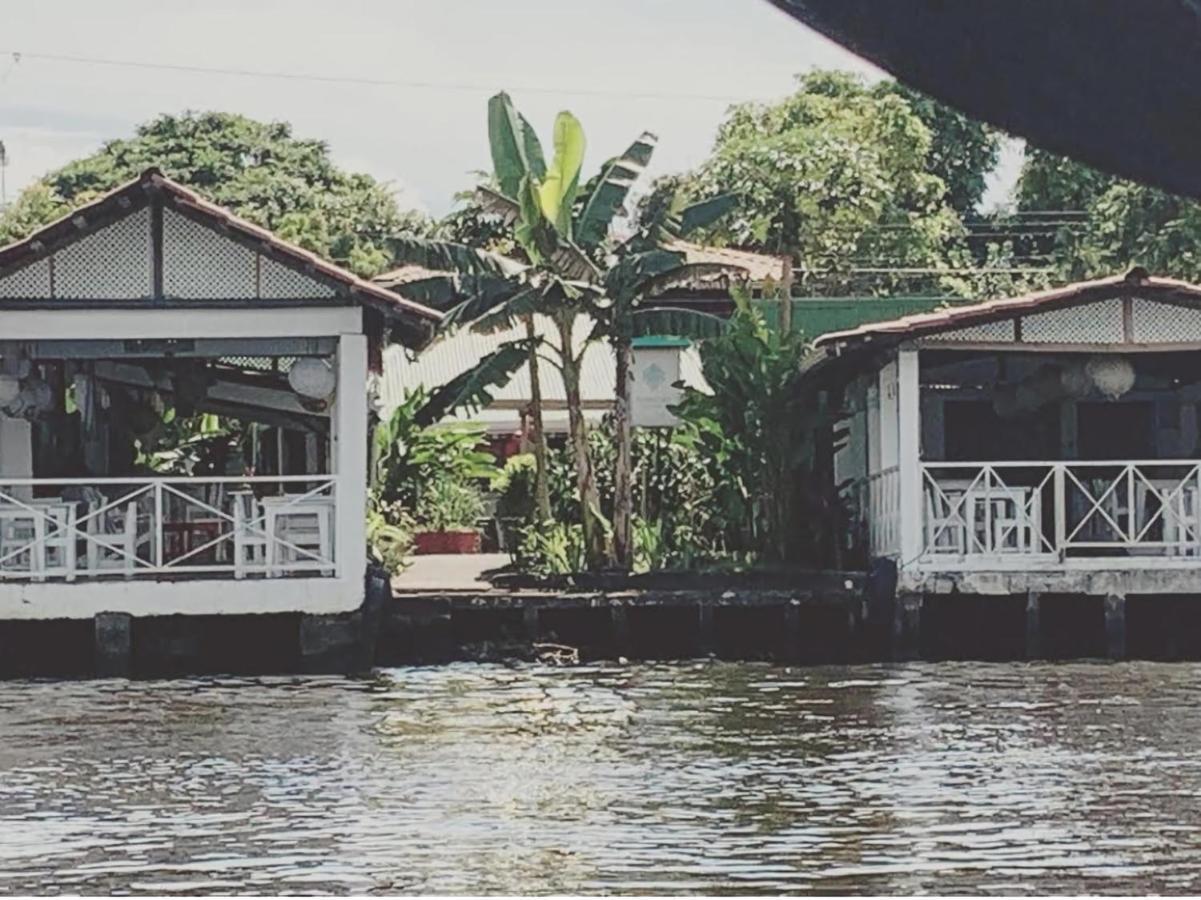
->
<box><xmin>0</xmin><ymin>475</ymin><xmax>336</xmax><ymax>582</ymax></box>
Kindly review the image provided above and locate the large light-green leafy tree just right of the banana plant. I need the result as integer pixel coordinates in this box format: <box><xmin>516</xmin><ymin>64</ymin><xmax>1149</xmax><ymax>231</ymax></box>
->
<box><xmin>644</xmin><ymin>72</ymin><xmax>962</xmax><ymax>293</ymax></box>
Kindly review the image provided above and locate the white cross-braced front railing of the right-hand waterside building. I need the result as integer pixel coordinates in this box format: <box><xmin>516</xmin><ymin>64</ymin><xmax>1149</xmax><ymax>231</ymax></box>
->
<box><xmin>921</xmin><ymin>459</ymin><xmax>1201</xmax><ymax>559</ymax></box>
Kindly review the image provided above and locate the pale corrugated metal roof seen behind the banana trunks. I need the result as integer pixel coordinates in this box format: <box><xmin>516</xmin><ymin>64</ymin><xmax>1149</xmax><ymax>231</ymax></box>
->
<box><xmin>378</xmin><ymin>316</ymin><xmax>705</xmax><ymax>429</ymax></box>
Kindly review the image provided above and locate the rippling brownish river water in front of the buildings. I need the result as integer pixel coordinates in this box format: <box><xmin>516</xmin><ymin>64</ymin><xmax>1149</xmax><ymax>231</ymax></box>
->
<box><xmin>0</xmin><ymin>663</ymin><xmax>1201</xmax><ymax>893</ymax></box>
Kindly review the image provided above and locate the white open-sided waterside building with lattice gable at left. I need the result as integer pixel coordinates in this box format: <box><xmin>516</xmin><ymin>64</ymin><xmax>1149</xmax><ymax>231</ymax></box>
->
<box><xmin>0</xmin><ymin>169</ymin><xmax>440</xmax><ymax>620</ymax></box>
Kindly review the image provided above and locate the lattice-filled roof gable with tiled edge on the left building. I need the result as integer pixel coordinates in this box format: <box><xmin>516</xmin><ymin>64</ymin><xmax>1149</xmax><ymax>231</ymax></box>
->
<box><xmin>0</xmin><ymin>169</ymin><xmax>441</xmax><ymax>341</ymax></box>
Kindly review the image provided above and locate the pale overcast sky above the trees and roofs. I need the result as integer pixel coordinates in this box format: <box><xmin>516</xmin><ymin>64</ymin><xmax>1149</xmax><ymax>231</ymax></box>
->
<box><xmin>0</xmin><ymin>0</ymin><xmax>1021</xmax><ymax>215</ymax></box>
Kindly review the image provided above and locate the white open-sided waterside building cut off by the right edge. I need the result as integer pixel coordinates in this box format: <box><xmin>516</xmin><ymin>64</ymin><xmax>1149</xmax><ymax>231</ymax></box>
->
<box><xmin>809</xmin><ymin>269</ymin><xmax>1201</xmax><ymax>596</ymax></box>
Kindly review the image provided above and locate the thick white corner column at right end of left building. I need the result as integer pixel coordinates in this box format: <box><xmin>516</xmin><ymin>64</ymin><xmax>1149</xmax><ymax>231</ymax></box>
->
<box><xmin>331</xmin><ymin>334</ymin><xmax>368</xmax><ymax>590</ymax></box>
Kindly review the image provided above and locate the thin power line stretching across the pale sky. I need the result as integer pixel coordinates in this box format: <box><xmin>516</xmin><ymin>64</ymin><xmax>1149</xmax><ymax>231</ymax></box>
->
<box><xmin>0</xmin><ymin>49</ymin><xmax>752</xmax><ymax>103</ymax></box>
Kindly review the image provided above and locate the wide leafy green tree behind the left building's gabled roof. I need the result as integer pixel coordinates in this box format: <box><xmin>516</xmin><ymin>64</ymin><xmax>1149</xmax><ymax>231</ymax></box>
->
<box><xmin>0</xmin><ymin>112</ymin><xmax>431</xmax><ymax>276</ymax></box>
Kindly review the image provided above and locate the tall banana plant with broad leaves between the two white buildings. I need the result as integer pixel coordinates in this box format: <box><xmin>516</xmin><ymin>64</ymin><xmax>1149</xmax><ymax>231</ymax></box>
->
<box><xmin>395</xmin><ymin>94</ymin><xmax>729</xmax><ymax>568</ymax></box>
